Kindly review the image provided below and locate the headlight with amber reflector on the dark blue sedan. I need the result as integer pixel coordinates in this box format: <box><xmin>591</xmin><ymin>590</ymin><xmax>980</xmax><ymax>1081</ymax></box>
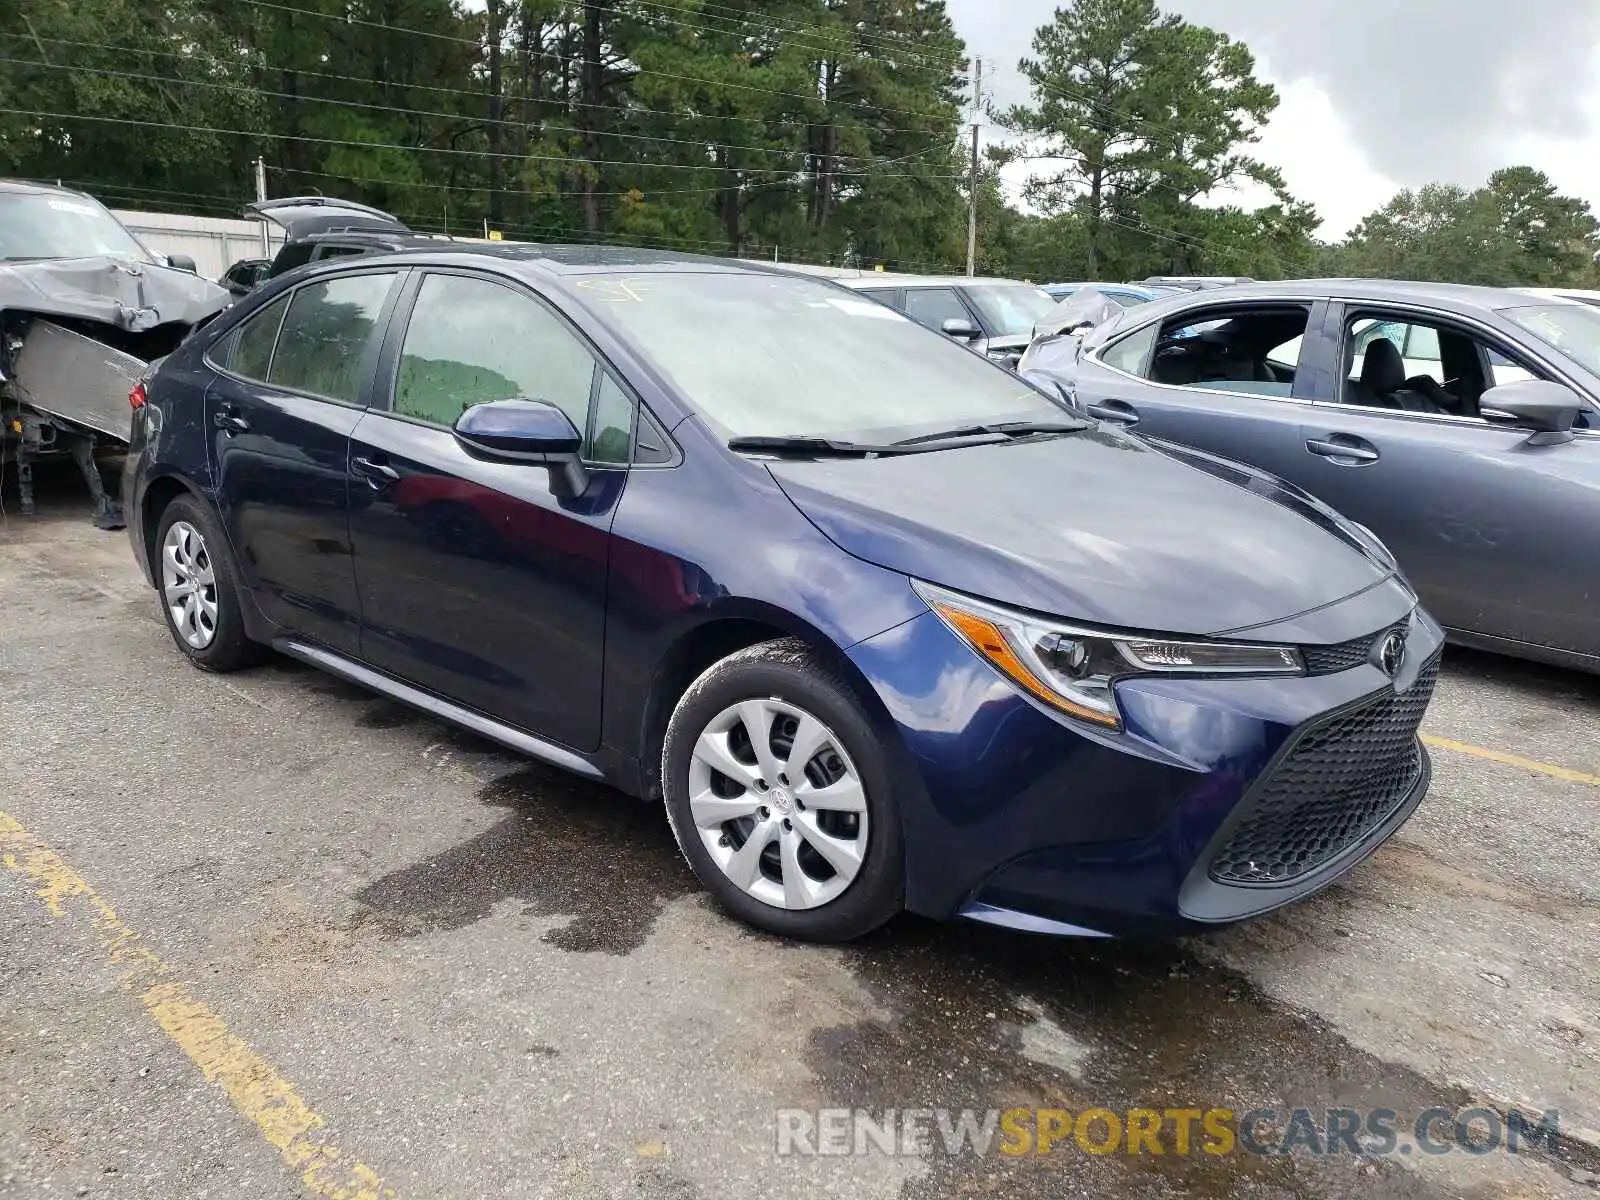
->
<box><xmin>912</xmin><ymin>579</ymin><xmax>1306</xmax><ymax>728</ymax></box>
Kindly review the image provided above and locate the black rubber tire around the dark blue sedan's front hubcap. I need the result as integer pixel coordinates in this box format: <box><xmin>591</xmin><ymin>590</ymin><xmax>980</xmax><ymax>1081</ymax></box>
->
<box><xmin>661</xmin><ymin>638</ymin><xmax>904</xmax><ymax>942</ymax></box>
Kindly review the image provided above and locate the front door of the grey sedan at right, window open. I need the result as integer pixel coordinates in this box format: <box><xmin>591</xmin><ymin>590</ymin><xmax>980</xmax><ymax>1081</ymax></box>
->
<box><xmin>1282</xmin><ymin>304</ymin><xmax>1600</xmax><ymax>653</ymax></box>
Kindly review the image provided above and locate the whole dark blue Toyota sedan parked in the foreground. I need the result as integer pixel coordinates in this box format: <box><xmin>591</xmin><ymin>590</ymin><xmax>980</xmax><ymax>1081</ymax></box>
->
<box><xmin>123</xmin><ymin>246</ymin><xmax>1442</xmax><ymax>939</ymax></box>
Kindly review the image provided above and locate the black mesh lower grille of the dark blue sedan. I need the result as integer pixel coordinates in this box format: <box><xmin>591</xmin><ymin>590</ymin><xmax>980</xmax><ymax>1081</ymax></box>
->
<box><xmin>1211</xmin><ymin>656</ymin><xmax>1438</xmax><ymax>883</ymax></box>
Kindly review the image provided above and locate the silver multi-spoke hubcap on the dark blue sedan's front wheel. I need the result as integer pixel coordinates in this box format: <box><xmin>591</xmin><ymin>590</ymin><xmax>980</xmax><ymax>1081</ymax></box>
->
<box><xmin>690</xmin><ymin>699</ymin><xmax>867</xmax><ymax>909</ymax></box>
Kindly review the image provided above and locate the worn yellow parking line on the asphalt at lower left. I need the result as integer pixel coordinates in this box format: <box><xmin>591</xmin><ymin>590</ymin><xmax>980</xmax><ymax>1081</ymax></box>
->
<box><xmin>0</xmin><ymin>813</ymin><xmax>395</xmax><ymax>1200</ymax></box>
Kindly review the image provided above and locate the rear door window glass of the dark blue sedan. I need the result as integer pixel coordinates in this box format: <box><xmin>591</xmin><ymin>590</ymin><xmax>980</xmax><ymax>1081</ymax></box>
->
<box><xmin>267</xmin><ymin>272</ymin><xmax>395</xmax><ymax>405</ymax></box>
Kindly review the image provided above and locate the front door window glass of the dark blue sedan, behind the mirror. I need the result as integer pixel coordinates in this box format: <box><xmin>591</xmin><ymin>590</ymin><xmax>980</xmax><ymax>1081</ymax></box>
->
<box><xmin>394</xmin><ymin>275</ymin><xmax>595</xmax><ymax>430</ymax></box>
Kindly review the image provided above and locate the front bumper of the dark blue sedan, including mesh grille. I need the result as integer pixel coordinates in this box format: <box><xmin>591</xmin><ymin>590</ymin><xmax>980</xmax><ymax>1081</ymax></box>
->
<box><xmin>851</xmin><ymin>586</ymin><xmax>1443</xmax><ymax>936</ymax></box>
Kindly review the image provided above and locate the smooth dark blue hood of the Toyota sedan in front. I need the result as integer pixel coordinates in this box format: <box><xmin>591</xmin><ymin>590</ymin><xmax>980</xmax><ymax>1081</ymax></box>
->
<box><xmin>768</xmin><ymin>427</ymin><xmax>1395</xmax><ymax>634</ymax></box>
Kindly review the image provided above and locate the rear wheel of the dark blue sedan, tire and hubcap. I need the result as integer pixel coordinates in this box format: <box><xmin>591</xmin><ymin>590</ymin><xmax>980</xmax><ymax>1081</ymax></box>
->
<box><xmin>155</xmin><ymin>496</ymin><xmax>267</xmax><ymax>672</ymax></box>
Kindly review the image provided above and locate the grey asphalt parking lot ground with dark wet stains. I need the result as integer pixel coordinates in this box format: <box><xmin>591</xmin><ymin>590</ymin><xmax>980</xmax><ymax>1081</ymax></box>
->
<box><xmin>0</xmin><ymin>472</ymin><xmax>1600</xmax><ymax>1200</ymax></box>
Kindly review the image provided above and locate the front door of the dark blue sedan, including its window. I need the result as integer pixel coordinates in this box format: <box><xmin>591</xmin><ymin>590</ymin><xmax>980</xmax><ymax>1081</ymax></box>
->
<box><xmin>349</xmin><ymin>270</ymin><xmax>634</xmax><ymax>750</ymax></box>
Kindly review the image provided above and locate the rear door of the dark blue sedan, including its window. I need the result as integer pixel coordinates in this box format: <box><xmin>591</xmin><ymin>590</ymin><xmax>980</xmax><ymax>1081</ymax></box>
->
<box><xmin>205</xmin><ymin>269</ymin><xmax>398</xmax><ymax>654</ymax></box>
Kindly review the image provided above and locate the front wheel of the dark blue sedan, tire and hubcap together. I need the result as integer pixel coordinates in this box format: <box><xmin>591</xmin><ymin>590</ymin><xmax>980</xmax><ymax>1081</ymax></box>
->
<box><xmin>661</xmin><ymin>640</ymin><xmax>902</xmax><ymax>941</ymax></box>
